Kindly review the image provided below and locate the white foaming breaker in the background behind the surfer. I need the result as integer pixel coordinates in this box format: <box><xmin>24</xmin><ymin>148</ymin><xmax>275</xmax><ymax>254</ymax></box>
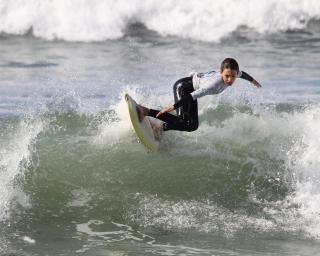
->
<box><xmin>0</xmin><ymin>0</ymin><xmax>320</xmax><ymax>42</ymax></box>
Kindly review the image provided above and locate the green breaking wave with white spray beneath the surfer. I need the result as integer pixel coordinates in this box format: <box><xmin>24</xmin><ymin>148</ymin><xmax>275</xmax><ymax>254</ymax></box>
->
<box><xmin>0</xmin><ymin>91</ymin><xmax>320</xmax><ymax>238</ymax></box>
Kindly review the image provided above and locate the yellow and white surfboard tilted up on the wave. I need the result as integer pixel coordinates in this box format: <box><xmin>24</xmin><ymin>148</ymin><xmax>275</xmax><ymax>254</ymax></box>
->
<box><xmin>124</xmin><ymin>93</ymin><xmax>159</xmax><ymax>152</ymax></box>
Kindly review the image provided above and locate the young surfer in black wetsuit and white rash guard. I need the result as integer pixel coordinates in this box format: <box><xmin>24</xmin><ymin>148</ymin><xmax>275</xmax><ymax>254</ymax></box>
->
<box><xmin>137</xmin><ymin>58</ymin><xmax>261</xmax><ymax>133</ymax></box>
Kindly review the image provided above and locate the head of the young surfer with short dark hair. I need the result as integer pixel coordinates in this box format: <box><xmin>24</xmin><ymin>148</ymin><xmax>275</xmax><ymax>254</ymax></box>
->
<box><xmin>220</xmin><ymin>58</ymin><xmax>239</xmax><ymax>86</ymax></box>
